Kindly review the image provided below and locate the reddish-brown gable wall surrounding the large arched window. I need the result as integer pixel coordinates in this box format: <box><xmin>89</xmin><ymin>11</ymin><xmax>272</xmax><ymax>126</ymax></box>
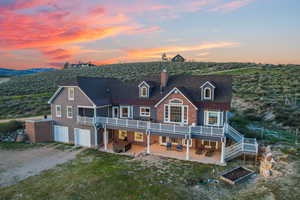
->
<box><xmin>156</xmin><ymin>93</ymin><xmax>197</xmax><ymax>125</ymax></box>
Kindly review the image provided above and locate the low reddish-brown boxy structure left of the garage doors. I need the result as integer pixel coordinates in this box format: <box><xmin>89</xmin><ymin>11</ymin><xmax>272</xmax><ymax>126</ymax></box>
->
<box><xmin>25</xmin><ymin>119</ymin><xmax>53</xmax><ymax>143</ymax></box>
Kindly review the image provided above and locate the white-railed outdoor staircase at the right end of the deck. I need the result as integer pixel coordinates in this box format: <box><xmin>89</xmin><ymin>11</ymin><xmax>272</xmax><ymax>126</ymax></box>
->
<box><xmin>225</xmin><ymin>124</ymin><xmax>258</xmax><ymax>161</ymax></box>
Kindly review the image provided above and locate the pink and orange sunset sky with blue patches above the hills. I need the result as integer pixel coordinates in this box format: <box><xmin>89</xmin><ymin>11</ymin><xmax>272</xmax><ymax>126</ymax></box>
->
<box><xmin>0</xmin><ymin>0</ymin><xmax>300</xmax><ymax>69</ymax></box>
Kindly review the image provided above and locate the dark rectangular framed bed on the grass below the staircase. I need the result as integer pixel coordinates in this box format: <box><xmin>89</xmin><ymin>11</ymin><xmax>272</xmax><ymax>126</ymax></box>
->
<box><xmin>221</xmin><ymin>166</ymin><xmax>255</xmax><ymax>185</ymax></box>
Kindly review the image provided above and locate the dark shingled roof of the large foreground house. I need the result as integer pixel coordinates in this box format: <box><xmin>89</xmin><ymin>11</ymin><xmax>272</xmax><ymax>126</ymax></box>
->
<box><xmin>51</xmin><ymin>74</ymin><xmax>232</xmax><ymax>110</ymax></box>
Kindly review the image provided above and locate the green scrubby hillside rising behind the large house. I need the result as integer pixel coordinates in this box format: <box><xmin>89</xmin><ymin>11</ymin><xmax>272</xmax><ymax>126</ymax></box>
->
<box><xmin>0</xmin><ymin>62</ymin><xmax>300</xmax><ymax>133</ymax></box>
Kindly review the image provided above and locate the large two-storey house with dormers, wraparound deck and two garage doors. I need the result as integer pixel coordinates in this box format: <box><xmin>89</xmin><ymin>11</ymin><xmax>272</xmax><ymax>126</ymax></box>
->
<box><xmin>49</xmin><ymin>70</ymin><xmax>257</xmax><ymax>165</ymax></box>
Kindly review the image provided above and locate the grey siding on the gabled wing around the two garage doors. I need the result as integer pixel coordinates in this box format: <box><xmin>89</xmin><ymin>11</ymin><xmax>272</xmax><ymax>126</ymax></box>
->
<box><xmin>51</xmin><ymin>87</ymin><xmax>99</xmax><ymax>146</ymax></box>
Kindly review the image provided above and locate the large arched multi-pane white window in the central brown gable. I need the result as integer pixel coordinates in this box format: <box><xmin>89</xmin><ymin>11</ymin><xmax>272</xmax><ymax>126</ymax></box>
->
<box><xmin>164</xmin><ymin>99</ymin><xmax>188</xmax><ymax>124</ymax></box>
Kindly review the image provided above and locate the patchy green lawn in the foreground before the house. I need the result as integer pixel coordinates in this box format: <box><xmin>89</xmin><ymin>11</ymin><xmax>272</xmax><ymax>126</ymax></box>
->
<box><xmin>0</xmin><ymin>147</ymin><xmax>300</xmax><ymax>200</ymax></box>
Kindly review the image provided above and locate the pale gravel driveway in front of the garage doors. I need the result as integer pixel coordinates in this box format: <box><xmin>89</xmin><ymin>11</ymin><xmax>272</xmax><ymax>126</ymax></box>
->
<box><xmin>0</xmin><ymin>145</ymin><xmax>81</xmax><ymax>187</ymax></box>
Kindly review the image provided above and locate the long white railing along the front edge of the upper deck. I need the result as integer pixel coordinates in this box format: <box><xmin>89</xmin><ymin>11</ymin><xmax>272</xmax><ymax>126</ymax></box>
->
<box><xmin>96</xmin><ymin>117</ymin><xmax>225</xmax><ymax>137</ymax></box>
